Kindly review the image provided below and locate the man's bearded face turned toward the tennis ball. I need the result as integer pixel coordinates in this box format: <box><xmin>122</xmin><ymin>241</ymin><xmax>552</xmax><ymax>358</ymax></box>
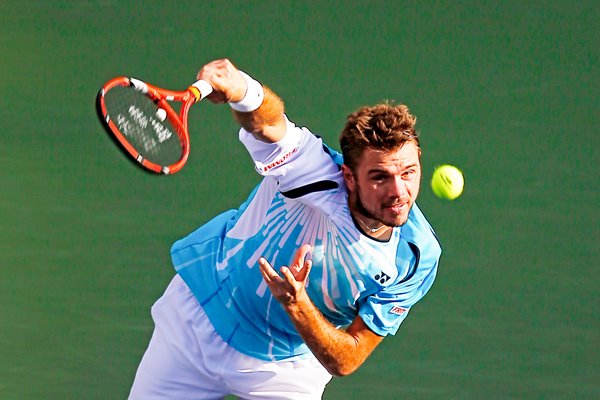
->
<box><xmin>342</xmin><ymin>142</ymin><xmax>421</xmax><ymax>226</ymax></box>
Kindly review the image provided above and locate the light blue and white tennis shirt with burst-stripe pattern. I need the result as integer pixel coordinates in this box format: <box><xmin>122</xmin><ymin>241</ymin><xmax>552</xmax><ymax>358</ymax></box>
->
<box><xmin>171</xmin><ymin>116</ymin><xmax>441</xmax><ymax>360</ymax></box>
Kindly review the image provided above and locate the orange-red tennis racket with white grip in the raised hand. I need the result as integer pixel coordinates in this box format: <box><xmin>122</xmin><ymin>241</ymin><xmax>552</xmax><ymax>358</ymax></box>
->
<box><xmin>96</xmin><ymin>76</ymin><xmax>212</xmax><ymax>175</ymax></box>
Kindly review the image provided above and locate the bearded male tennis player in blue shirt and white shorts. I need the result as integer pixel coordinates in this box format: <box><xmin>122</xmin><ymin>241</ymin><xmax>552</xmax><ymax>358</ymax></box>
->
<box><xmin>130</xmin><ymin>60</ymin><xmax>441</xmax><ymax>400</ymax></box>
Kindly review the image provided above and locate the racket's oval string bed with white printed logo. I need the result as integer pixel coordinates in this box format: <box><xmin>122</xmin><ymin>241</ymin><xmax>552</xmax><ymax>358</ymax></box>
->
<box><xmin>104</xmin><ymin>86</ymin><xmax>182</xmax><ymax>166</ymax></box>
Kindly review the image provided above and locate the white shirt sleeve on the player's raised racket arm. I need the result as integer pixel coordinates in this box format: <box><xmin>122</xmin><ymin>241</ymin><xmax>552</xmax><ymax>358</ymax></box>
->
<box><xmin>239</xmin><ymin>117</ymin><xmax>341</xmax><ymax>192</ymax></box>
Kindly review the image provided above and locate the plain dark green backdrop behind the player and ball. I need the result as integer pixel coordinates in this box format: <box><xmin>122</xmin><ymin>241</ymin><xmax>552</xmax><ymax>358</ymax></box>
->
<box><xmin>0</xmin><ymin>0</ymin><xmax>600</xmax><ymax>399</ymax></box>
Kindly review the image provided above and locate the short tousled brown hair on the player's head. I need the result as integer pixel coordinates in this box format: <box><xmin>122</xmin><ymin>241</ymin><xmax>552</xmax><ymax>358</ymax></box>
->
<box><xmin>340</xmin><ymin>102</ymin><xmax>420</xmax><ymax>170</ymax></box>
